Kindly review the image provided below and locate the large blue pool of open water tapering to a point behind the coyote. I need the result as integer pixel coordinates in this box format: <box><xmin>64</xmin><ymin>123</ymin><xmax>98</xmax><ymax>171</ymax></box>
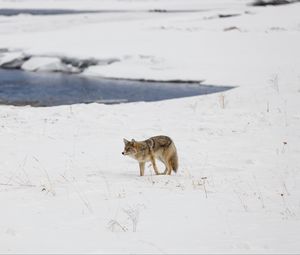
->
<box><xmin>0</xmin><ymin>69</ymin><xmax>233</xmax><ymax>106</ymax></box>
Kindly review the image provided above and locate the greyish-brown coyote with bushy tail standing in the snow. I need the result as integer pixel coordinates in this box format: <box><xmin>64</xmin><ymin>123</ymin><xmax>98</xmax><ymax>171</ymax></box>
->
<box><xmin>122</xmin><ymin>135</ymin><xmax>178</xmax><ymax>176</ymax></box>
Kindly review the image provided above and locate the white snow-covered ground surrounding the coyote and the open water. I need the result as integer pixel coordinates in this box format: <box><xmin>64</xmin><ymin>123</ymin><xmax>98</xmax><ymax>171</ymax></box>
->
<box><xmin>0</xmin><ymin>0</ymin><xmax>300</xmax><ymax>253</ymax></box>
